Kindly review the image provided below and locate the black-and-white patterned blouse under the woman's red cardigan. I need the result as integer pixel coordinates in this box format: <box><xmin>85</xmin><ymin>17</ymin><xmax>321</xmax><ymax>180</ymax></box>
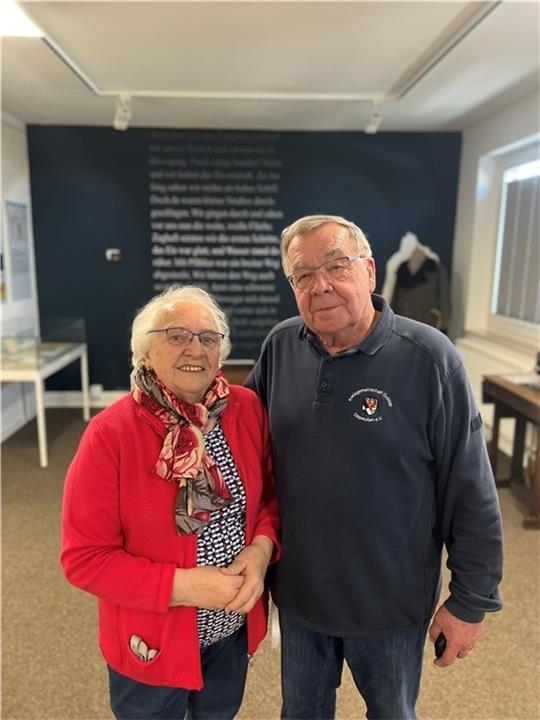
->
<box><xmin>197</xmin><ymin>423</ymin><xmax>246</xmax><ymax>647</ymax></box>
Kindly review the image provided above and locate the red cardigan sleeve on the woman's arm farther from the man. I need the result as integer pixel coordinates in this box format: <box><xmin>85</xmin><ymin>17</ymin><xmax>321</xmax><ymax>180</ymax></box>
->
<box><xmin>60</xmin><ymin>419</ymin><xmax>176</xmax><ymax>612</ymax></box>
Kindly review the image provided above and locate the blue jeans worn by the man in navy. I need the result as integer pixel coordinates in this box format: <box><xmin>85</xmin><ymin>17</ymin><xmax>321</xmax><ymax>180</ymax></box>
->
<box><xmin>279</xmin><ymin>611</ymin><xmax>427</xmax><ymax>720</ymax></box>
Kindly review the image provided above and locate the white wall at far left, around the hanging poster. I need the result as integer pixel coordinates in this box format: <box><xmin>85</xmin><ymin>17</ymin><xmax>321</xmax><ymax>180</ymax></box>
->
<box><xmin>1</xmin><ymin>113</ymin><xmax>39</xmax><ymax>441</ymax></box>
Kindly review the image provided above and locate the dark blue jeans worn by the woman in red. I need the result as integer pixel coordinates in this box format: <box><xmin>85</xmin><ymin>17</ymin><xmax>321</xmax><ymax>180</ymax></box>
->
<box><xmin>109</xmin><ymin>624</ymin><xmax>248</xmax><ymax>720</ymax></box>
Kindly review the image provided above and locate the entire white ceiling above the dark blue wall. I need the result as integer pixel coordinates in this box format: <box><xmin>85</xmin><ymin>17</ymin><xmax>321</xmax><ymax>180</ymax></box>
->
<box><xmin>2</xmin><ymin>0</ymin><xmax>540</xmax><ymax>131</ymax></box>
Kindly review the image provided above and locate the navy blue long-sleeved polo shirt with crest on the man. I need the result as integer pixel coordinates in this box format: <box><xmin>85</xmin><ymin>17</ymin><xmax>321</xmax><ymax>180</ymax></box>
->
<box><xmin>246</xmin><ymin>295</ymin><xmax>502</xmax><ymax>635</ymax></box>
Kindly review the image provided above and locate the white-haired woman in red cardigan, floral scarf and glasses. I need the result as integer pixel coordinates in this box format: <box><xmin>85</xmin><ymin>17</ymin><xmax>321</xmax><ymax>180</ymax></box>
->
<box><xmin>61</xmin><ymin>287</ymin><xmax>278</xmax><ymax>720</ymax></box>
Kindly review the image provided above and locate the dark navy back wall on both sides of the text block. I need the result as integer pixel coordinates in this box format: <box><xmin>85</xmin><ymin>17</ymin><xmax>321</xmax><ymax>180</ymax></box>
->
<box><xmin>28</xmin><ymin>126</ymin><xmax>461</xmax><ymax>389</ymax></box>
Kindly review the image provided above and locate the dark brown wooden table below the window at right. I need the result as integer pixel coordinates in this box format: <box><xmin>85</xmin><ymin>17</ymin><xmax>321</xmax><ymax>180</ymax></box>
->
<box><xmin>482</xmin><ymin>375</ymin><xmax>540</xmax><ymax>528</ymax></box>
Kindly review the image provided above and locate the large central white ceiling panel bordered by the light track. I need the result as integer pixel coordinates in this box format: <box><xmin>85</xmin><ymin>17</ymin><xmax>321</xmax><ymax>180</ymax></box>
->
<box><xmin>20</xmin><ymin>2</ymin><xmax>466</xmax><ymax>94</ymax></box>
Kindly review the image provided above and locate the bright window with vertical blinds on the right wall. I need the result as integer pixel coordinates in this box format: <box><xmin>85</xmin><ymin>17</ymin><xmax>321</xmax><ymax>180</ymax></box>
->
<box><xmin>491</xmin><ymin>160</ymin><xmax>540</xmax><ymax>324</ymax></box>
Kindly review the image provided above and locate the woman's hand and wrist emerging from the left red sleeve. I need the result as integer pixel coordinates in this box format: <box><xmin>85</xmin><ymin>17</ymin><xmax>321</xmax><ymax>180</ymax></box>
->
<box><xmin>170</xmin><ymin>565</ymin><xmax>244</xmax><ymax>610</ymax></box>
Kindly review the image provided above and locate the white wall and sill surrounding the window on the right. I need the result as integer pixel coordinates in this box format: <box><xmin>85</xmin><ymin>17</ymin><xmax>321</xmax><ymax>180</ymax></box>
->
<box><xmin>450</xmin><ymin>87</ymin><xmax>540</xmax><ymax>451</ymax></box>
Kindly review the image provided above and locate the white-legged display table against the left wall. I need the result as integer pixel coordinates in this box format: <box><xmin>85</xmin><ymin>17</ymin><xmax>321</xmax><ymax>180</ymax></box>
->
<box><xmin>0</xmin><ymin>340</ymin><xmax>90</xmax><ymax>467</ymax></box>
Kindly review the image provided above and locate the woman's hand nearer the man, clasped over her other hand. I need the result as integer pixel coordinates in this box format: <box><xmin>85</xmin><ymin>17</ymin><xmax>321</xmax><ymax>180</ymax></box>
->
<box><xmin>221</xmin><ymin>535</ymin><xmax>274</xmax><ymax>613</ymax></box>
